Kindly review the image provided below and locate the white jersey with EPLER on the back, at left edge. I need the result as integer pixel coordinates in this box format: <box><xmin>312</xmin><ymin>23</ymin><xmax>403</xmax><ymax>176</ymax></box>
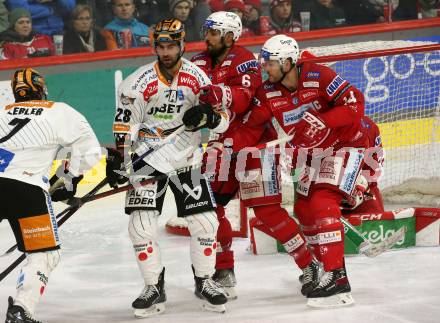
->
<box><xmin>0</xmin><ymin>100</ymin><xmax>101</xmax><ymax>191</ymax></box>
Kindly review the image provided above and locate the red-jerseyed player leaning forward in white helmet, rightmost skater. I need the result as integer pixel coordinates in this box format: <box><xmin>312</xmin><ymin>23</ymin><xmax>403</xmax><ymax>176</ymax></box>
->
<box><xmin>237</xmin><ymin>35</ymin><xmax>368</xmax><ymax>307</ymax></box>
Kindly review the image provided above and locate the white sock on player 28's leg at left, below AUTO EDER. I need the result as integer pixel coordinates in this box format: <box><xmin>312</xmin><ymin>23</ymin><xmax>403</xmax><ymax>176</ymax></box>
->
<box><xmin>128</xmin><ymin>210</ymin><xmax>163</xmax><ymax>285</ymax></box>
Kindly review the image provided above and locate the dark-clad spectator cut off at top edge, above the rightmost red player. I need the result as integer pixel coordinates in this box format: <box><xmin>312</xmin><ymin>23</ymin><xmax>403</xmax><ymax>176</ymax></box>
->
<box><xmin>302</xmin><ymin>0</ymin><xmax>345</xmax><ymax>30</ymax></box>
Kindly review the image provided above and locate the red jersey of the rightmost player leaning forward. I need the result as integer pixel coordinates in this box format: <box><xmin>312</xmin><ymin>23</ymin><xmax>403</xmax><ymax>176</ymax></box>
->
<box><xmin>241</xmin><ymin>62</ymin><xmax>368</xmax><ymax>149</ymax></box>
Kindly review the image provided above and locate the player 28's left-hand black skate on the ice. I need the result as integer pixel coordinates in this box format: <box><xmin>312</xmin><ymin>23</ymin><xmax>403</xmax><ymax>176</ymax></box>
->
<box><xmin>131</xmin><ymin>268</ymin><xmax>167</xmax><ymax>318</ymax></box>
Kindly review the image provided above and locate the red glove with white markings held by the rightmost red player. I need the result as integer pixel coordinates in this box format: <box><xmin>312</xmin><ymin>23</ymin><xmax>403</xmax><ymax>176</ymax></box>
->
<box><xmin>292</xmin><ymin>110</ymin><xmax>330</xmax><ymax>148</ymax></box>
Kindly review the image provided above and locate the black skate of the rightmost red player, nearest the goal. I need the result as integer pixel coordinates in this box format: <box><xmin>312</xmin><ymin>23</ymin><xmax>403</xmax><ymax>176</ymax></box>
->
<box><xmin>307</xmin><ymin>268</ymin><xmax>354</xmax><ymax>308</ymax></box>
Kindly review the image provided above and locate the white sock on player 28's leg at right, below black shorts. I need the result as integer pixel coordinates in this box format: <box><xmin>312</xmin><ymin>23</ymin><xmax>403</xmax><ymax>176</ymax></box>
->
<box><xmin>186</xmin><ymin>211</ymin><xmax>218</xmax><ymax>277</ymax></box>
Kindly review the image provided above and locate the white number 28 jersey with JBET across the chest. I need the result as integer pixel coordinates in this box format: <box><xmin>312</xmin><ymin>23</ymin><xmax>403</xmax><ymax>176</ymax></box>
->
<box><xmin>113</xmin><ymin>58</ymin><xmax>229</xmax><ymax>173</ymax></box>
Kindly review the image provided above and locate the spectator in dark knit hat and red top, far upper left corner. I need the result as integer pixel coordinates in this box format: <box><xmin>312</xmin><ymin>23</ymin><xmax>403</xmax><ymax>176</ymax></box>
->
<box><xmin>0</xmin><ymin>8</ymin><xmax>55</xmax><ymax>59</ymax></box>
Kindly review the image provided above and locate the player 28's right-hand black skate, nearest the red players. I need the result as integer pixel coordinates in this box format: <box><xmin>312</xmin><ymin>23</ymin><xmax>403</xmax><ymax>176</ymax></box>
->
<box><xmin>194</xmin><ymin>276</ymin><xmax>228</xmax><ymax>313</ymax></box>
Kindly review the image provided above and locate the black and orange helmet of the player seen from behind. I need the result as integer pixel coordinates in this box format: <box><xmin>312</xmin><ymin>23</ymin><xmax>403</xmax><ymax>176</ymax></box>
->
<box><xmin>11</xmin><ymin>68</ymin><xmax>47</xmax><ymax>102</ymax></box>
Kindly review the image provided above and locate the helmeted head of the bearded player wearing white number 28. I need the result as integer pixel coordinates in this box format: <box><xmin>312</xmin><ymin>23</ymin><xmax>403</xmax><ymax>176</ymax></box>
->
<box><xmin>153</xmin><ymin>19</ymin><xmax>185</xmax><ymax>82</ymax></box>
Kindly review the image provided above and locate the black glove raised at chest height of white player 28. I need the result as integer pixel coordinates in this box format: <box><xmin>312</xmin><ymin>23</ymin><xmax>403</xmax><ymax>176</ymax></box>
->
<box><xmin>182</xmin><ymin>104</ymin><xmax>221</xmax><ymax>131</ymax></box>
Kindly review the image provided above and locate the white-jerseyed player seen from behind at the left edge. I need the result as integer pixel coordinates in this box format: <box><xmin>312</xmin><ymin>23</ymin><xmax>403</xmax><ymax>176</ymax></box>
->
<box><xmin>0</xmin><ymin>68</ymin><xmax>101</xmax><ymax>323</ymax></box>
